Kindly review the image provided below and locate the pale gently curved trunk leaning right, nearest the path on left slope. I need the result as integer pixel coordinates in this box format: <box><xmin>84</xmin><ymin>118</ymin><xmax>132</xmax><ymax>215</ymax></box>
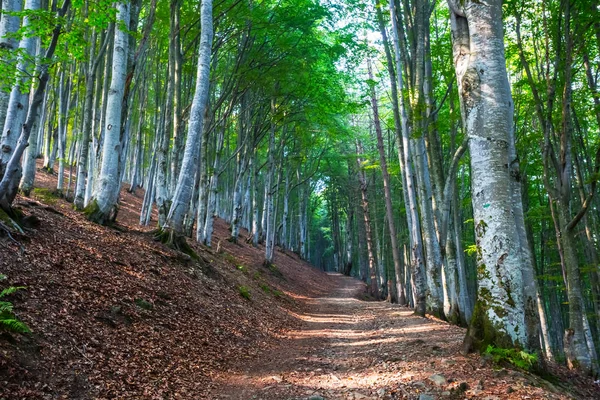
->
<box><xmin>163</xmin><ymin>0</ymin><xmax>213</xmax><ymax>235</ymax></box>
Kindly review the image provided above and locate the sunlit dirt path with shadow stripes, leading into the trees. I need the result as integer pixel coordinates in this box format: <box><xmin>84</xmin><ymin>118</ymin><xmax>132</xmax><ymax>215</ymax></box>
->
<box><xmin>211</xmin><ymin>275</ymin><xmax>570</xmax><ymax>400</ymax></box>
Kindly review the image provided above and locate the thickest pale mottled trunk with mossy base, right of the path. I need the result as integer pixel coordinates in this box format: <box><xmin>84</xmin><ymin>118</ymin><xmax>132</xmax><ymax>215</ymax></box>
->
<box><xmin>448</xmin><ymin>0</ymin><xmax>530</xmax><ymax>351</ymax></box>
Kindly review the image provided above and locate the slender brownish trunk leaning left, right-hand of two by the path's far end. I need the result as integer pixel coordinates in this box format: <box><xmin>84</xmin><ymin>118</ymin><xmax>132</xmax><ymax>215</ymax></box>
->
<box><xmin>368</xmin><ymin>59</ymin><xmax>406</xmax><ymax>304</ymax></box>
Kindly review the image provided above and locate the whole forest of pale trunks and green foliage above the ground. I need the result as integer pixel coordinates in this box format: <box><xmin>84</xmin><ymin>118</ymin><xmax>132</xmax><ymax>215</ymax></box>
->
<box><xmin>0</xmin><ymin>0</ymin><xmax>600</xmax><ymax>399</ymax></box>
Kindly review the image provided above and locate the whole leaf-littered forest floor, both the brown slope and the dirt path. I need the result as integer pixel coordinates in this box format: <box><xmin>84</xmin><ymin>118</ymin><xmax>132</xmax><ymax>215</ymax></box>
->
<box><xmin>0</xmin><ymin>161</ymin><xmax>600</xmax><ymax>400</ymax></box>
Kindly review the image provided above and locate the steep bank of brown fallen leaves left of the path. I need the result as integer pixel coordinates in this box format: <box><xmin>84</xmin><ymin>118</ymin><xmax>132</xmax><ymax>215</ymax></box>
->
<box><xmin>0</xmin><ymin>173</ymin><xmax>338</xmax><ymax>399</ymax></box>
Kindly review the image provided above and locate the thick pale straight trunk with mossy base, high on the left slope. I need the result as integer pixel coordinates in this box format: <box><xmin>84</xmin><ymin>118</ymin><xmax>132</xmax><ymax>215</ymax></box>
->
<box><xmin>86</xmin><ymin>1</ymin><xmax>130</xmax><ymax>224</ymax></box>
